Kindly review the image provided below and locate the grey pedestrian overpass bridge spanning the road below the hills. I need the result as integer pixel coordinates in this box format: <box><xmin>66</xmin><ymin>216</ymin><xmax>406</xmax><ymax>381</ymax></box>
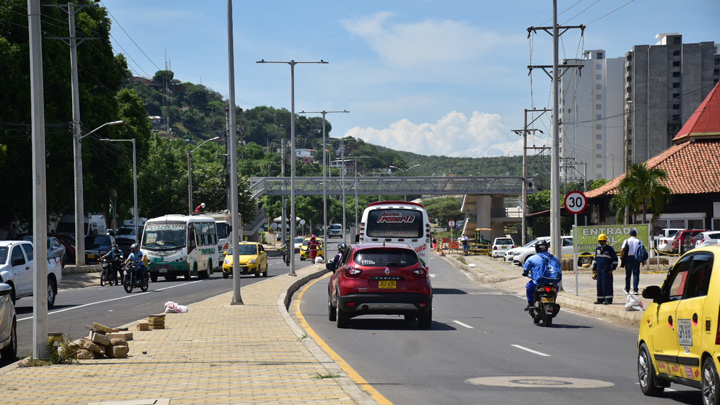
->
<box><xmin>250</xmin><ymin>176</ymin><xmax>537</xmax><ymax>239</ymax></box>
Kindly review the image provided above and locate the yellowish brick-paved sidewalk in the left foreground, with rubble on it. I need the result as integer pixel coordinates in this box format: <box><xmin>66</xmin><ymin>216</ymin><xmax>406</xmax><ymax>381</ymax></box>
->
<box><xmin>0</xmin><ymin>265</ymin><xmax>375</xmax><ymax>405</ymax></box>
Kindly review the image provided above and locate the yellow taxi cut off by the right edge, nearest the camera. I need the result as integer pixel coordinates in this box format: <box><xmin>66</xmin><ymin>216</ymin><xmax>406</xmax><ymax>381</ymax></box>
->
<box><xmin>637</xmin><ymin>245</ymin><xmax>720</xmax><ymax>405</ymax></box>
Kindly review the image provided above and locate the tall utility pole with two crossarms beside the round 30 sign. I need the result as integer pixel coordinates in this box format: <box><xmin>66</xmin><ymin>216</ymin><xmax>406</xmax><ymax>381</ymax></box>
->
<box><xmin>527</xmin><ymin>5</ymin><xmax>585</xmax><ymax>257</ymax></box>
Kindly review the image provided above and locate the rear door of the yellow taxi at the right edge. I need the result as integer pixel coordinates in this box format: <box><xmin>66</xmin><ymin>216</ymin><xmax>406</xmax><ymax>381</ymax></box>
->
<box><xmin>677</xmin><ymin>252</ymin><xmax>718</xmax><ymax>381</ymax></box>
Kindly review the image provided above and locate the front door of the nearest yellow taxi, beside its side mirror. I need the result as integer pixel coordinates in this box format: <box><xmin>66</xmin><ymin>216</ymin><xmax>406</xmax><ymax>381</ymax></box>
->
<box><xmin>648</xmin><ymin>256</ymin><xmax>692</xmax><ymax>378</ymax></box>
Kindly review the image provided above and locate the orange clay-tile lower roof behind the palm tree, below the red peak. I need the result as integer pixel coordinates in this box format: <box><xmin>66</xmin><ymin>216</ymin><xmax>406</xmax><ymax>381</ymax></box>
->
<box><xmin>585</xmin><ymin>140</ymin><xmax>720</xmax><ymax>198</ymax></box>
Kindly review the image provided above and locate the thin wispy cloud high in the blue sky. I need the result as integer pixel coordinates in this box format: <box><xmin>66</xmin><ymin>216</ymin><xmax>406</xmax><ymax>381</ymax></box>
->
<box><xmin>343</xmin><ymin>12</ymin><xmax>525</xmax><ymax>67</ymax></box>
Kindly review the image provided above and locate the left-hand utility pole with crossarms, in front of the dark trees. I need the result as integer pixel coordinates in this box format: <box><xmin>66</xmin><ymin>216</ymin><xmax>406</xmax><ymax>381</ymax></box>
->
<box><xmin>45</xmin><ymin>3</ymin><xmax>99</xmax><ymax>266</ymax></box>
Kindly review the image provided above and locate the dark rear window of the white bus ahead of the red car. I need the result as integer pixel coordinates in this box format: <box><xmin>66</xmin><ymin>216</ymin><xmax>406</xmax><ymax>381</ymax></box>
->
<box><xmin>366</xmin><ymin>208</ymin><xmax>423</xmax><ymax>238</ymax></box>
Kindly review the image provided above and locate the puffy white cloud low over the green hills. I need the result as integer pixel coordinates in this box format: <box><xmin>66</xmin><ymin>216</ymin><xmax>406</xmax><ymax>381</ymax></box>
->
<box><xmin>345</xmin><ymin>111</ymin><xmax>522</xmax><ymax>157</ymax></box>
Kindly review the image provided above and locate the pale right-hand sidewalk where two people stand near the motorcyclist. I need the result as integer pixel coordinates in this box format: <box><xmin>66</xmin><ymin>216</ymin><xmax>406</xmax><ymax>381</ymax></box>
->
<box><xmin>432</xmin><ymin>253</ymin><xmax>668</xmax><ymax>325</ymax></box>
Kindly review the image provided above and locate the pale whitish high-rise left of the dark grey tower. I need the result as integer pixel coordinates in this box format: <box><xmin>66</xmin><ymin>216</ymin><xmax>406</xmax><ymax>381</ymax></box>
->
<box><xmin>559</xmin><ymin>50</ymin><xmax>625</xmax><ymax>179</ymax></box>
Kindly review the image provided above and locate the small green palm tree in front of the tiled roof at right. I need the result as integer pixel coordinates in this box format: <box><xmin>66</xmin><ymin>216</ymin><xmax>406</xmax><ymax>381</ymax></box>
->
<box><xmin>610</xmin><ymin>163</ymin><xmax>670</xmax><ymax>224</ymax></box>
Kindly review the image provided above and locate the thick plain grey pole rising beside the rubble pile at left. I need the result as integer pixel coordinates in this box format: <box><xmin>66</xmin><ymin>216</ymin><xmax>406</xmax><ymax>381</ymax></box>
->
<box><xmin>28</xmin><ymin>0</ymin><xmax>48</xmax><ymax>359</ymax></box>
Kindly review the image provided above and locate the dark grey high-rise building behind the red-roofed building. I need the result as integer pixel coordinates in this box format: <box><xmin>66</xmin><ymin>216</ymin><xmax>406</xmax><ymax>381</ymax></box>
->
<box><xmin>623</xmin><ymin>34</ymin><xmax>720</xmax><ymax>165</ymax></box>
